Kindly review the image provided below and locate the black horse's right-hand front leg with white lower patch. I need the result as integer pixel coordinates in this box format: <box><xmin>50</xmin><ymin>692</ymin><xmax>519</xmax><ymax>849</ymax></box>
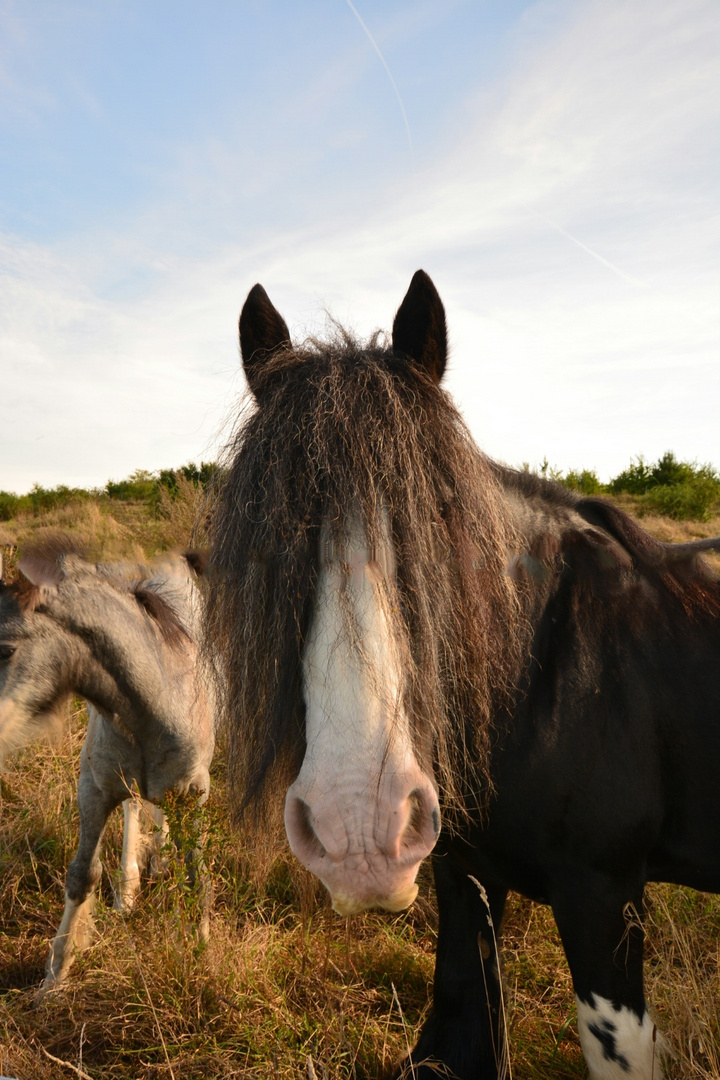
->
<box><xmin>551</xmin><ymin>869</ymin><xmax>664</xmax><ymax>1080</ymax></box>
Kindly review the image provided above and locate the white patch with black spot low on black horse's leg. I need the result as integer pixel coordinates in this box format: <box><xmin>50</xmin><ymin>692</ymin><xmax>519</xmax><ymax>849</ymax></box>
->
<box><xmin>575</xmin><ymin>994</ymin><xmax>664</xmax><ymax>1080</ymax></box>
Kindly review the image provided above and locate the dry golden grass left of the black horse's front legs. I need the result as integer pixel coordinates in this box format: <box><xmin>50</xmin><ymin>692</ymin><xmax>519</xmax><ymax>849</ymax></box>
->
<box><xmin>0</xmin><ymin>714</ymin><xmax>434</xmax><ymax>1080</ymax></box>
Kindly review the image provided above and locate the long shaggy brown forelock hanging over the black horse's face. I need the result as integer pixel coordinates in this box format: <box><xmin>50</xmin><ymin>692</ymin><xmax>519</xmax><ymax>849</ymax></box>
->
<box><xmin>207</xmin><ymin>330</ymin><xmax>521</xmax><ymax>829</ymax></box>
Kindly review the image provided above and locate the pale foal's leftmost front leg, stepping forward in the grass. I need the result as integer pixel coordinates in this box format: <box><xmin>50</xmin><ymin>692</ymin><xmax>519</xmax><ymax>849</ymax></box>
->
<box><xmin>40</xmin><ymin>769</ymin><xmax>119</xmax><ymax>996</ymax></box>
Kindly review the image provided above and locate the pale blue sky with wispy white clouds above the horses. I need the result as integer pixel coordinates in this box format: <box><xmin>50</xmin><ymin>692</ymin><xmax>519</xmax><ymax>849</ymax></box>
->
<box><xmin>0</xmin><ymin>0</ymin><xmax>720</xmax><ymax>494</ymax></box>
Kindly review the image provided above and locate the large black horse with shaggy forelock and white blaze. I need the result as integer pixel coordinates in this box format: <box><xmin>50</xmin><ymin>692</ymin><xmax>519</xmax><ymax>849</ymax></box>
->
<box><xmin>207</xmin><ymin>271</ymin><xmax>720</xmax><ymax>1080</ymax></box>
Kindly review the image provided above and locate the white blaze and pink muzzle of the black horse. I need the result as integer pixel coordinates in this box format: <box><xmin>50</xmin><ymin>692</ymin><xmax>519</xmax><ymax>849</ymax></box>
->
<box><xmin>286</xmin><ymin>514</ymin><xmax>439</xmax><ymax>914</ymax></box>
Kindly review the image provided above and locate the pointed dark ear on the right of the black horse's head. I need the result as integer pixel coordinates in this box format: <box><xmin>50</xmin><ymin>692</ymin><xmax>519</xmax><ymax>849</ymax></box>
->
<box><xmin>393</xmin><ymin>270</ymin><xmax>448</xmax><ymax>382</ymax></box>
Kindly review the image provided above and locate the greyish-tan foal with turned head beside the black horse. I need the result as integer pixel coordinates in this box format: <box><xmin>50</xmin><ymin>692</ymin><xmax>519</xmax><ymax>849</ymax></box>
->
<box><xmin>0</xmin><ymin>538</ymin><xmax>215</xmax><ymax>997</ymax></box>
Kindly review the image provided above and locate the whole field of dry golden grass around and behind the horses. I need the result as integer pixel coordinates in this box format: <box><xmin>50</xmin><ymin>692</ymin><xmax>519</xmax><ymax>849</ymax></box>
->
<box><xmin>0</xmin><ymin>466</ymin><xmax>720</xmax><ymax>1080</ymax></box>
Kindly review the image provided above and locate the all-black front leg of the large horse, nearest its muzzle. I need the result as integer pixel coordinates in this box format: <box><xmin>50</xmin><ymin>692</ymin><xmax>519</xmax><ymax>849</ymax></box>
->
<box><xmin>397</xmin><ymin>853</ymin><xmax>507</xmax><ymax>1080</ymax></box>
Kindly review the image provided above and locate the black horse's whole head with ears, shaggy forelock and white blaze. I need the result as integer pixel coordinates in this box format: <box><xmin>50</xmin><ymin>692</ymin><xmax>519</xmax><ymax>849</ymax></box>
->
<box><xmin>208</xmin><ymin>271</ymin><xmax>520</xmax><ymax>914</ymax></box>
